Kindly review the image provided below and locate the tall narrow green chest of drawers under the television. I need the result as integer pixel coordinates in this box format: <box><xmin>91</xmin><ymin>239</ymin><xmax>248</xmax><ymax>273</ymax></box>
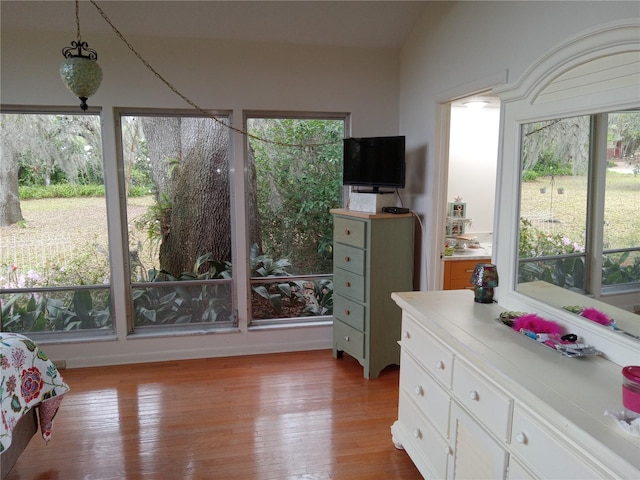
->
<box><xmin>331</xmin><ymin>210</ymin><xmax>415</xmax><ymax>378</ymax></box>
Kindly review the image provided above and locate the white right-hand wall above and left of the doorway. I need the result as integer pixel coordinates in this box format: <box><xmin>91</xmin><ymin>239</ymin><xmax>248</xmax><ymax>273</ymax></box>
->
<box><xmin>400</xmin><ymin>1</ymin><xmax>638</xmax><ymax>289</ymax></box>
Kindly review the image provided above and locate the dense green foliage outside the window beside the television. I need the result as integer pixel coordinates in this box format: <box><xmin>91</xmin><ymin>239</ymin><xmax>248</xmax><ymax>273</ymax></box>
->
<box><xmin>249</xmin><ymin>119</ymin><xmax>344</xmax><ymax>274</ymax></box>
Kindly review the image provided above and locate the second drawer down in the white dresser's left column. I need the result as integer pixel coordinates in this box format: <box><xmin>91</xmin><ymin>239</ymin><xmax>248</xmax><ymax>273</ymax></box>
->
<box><xmin>400</xmin><ymin>349</ymin><xmax>451</xmax><ymax>438</ymax></box>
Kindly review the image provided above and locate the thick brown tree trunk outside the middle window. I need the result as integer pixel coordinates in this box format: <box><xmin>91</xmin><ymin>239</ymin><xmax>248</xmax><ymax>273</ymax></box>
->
<box><xmin>142</xmin><ymin>117</ymin><xmax>256</xmax><ymax>276</ymax></box>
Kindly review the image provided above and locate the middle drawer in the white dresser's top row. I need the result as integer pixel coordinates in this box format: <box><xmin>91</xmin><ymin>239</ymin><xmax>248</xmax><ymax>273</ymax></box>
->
<box><xmin>453</xmin><ymin>360</ymin><xmax>513</xmax><ymax>441</ymax></box>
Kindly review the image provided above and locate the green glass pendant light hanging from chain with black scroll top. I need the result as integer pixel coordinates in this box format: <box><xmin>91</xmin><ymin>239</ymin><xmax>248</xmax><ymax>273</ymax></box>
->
<box><xmin>60</xmin><ymin>0</ymin><xmax>102</xmax><ymax>110</ymax></box>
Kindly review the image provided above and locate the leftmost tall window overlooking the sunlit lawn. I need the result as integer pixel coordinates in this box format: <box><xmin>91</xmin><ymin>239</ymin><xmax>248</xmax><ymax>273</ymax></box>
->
<box><xmin>0</xmin><ymin>109</ymin><xmax>113</xmax><ymax>336</ymax></box>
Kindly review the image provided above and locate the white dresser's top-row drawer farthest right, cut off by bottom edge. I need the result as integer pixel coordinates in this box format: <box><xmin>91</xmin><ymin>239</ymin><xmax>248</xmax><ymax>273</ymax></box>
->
<box><xmin>511</xmin><ymin>405</ymin><xmax>611</xmax><ymax>480</ymax></box>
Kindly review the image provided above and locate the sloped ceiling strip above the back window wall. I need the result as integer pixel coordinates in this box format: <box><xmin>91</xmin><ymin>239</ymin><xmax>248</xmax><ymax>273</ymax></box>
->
<box><xmin>0</xmin><ymin>0</ymin><xmax>429</xmax><ymax>48</ymax></box>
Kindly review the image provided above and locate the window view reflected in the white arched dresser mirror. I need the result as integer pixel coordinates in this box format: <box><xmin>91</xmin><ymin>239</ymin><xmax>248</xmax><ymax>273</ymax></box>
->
<box><xmin>518</xmin><ymin>111</ymin><xmax>640</xmax><ymax>296</ymax></box>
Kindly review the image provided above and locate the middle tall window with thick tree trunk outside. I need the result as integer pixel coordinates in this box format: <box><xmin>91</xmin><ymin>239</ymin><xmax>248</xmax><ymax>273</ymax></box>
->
<box><xmin>120</xmin><ymin>112</ymin><xmax>237</xmax><ymax>331</ymax></box>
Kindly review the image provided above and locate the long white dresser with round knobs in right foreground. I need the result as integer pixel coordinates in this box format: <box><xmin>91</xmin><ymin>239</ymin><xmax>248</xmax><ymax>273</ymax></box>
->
<box><xmin>391</xmin><ymin>290</ymin><xmax>640</xmax><ymax>480</ymax></box>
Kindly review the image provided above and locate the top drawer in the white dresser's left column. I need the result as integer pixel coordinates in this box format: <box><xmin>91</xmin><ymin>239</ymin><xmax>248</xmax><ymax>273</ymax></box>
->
<box><xmin>402</xmin><ymin>312</ymin><xmax>453</xmax><ymax>388</ymax></box>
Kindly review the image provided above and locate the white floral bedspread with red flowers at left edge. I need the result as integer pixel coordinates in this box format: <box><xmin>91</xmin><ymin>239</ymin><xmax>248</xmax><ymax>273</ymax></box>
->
<box><xmin>0</xmin><ymin>332</ymin><xmax>69</xmax><ymax>452</ymax></box>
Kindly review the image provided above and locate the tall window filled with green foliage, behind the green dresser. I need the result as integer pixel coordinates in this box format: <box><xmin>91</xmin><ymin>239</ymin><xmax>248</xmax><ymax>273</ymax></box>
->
<box><xmin>247</xmin><ymin>114</ymin><xmax>345</xmax><ymax>325</ymax></box>
